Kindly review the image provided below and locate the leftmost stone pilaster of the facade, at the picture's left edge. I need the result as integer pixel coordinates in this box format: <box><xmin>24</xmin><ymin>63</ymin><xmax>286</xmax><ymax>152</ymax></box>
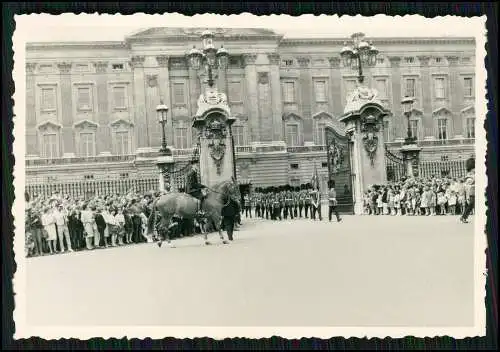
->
<box><xmin>26</xmin><ymin>62</ymin><xmax>39</xmax><ymax>155</ymax></box>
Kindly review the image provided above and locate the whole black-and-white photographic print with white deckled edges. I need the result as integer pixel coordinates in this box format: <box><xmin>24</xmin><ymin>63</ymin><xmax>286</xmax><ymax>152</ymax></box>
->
<box><xmin>12</xmin><ymin>13</ymin><xmax>487</xmax><ymax>339</ymax></box>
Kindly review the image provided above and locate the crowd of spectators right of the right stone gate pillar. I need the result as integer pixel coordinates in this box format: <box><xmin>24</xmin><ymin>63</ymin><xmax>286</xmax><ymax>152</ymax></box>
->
<box><xmin>363</xmin><ymin>174</ymin><xmax>474</xmax><ymax>220</ymax></box>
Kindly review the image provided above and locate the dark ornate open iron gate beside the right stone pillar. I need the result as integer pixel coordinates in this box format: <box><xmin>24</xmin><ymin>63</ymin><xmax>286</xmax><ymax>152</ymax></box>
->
<box><xmin>325</xmin><ymin>127</ymin><xmax>355</xmax><ymax>214</ymax></box>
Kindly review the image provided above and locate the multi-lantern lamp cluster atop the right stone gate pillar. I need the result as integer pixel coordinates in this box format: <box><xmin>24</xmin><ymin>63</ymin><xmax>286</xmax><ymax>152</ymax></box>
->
<box><xmin>340</xmin><ymin>33</ymin><xmax>379</xmax><ymax>83</ymax></box>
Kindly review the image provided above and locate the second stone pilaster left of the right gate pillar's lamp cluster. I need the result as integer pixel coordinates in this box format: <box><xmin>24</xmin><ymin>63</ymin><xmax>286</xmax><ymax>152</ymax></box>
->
<box><xmin>297</xmin><ymin>57</ymin><xmax>314</xmax><ymax>143</ymax></box>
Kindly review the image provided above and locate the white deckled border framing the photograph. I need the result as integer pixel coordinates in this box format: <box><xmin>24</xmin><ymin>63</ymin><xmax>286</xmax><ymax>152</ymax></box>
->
<box><xmin>12</xmin><ymin>14</ymin><xmax>487</xmax><ymax>339</ymax></box>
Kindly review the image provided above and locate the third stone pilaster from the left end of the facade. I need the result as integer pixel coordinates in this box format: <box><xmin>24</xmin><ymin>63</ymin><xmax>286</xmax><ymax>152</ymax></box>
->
<box><xmin>94</xmin><ymin>61</ymin><xmax>112</xmax><ymax>153</ymax></box>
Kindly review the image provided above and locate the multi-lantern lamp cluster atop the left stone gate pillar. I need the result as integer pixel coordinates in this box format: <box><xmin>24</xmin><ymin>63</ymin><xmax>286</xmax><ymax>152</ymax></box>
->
<box><xmin>187</xmin><ymin>31</ymin><xmax>229</xmax><ymax>88</ymax></box>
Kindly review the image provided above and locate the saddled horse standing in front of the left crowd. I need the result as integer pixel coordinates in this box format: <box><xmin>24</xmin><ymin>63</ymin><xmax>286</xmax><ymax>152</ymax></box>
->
<box><xmin>145</xmin><ymin>180</ymin><xmax>237</xmax><ymax>247</ymax></box>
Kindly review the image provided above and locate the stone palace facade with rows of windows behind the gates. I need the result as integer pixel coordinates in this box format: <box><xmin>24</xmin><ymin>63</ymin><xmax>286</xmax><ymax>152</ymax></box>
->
<box><xmin>25</xmin><ymin>28</ymin><xmax>475</xmax><ymax>191</ymax></box>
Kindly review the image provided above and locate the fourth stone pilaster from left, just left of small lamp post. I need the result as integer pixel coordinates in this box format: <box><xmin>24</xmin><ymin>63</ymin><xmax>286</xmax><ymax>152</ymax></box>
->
<box><xmin>130</xmin><ymin>56</ymin><xmax>149</xmax><ymax>148</ymax></box>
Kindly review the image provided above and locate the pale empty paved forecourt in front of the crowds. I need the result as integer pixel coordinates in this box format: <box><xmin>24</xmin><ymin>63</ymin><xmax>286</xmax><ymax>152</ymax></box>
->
<box><xmin>27</xmin><ymin>216</ymin><xmax>473</xmax><ymax>326</ymax></box>
